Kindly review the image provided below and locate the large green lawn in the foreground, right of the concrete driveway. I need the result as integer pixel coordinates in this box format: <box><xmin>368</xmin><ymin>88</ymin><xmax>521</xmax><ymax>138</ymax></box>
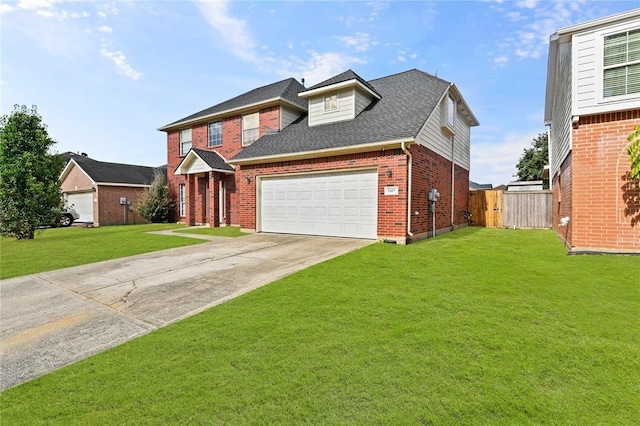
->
<box><xmin>0</xmin><ymin>228</ymin><xmax>640</xmax><ymax>425</ymax></box>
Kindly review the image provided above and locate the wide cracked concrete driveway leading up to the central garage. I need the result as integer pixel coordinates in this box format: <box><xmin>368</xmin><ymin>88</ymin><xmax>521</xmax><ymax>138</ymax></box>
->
<box><xmin>0</xmin><ymin>234</ymin><xmax>373</xmax><ymax>390</ymax></box>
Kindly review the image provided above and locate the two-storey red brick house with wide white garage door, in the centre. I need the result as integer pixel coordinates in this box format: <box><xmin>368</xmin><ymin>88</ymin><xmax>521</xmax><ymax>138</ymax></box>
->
<box><xmin>159</xmin><ymin>70</ymin><xmax>478</xmax><ymax>243</ymax></box>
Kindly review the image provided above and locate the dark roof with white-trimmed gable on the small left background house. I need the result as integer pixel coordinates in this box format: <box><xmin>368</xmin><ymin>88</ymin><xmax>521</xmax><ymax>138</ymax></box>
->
<box><xmin>60</xmin><ymin>153</ymin><xmax>166</xmax><ymax>186</ymax></box>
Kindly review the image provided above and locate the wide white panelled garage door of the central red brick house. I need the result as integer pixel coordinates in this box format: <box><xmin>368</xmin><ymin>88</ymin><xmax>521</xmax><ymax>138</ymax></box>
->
<box><xmin>260</xmin><ymin>170</ymin><xmax>378</xmax><ymax>239</ymax></box>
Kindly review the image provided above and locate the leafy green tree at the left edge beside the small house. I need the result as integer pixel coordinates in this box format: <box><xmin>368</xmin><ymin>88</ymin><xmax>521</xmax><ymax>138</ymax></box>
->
<box><xmin>0</xmin><ymin>105</ymin><xmax>64</xmax><ymax>240</ymax></box>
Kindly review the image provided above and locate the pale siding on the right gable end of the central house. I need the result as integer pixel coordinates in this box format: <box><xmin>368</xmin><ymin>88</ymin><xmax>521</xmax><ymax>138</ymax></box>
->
<box><xmin>416</xmin><ymin>96</ymin><xmax>471</xmax><ymax>170</ymax></box>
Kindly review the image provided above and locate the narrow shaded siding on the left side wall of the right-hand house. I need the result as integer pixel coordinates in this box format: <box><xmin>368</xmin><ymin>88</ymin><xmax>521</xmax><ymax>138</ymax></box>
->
<box><xmin>549</xmin><ymin>43</ymin><xmax>572</xmax><ymax>180</ymax></box>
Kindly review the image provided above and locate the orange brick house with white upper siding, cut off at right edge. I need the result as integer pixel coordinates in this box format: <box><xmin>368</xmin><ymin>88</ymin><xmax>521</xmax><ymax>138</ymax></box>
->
<box><xmin>545</xmin><ymin>9</ymin><xmax>640</xmax><ymax>253</ymax></box>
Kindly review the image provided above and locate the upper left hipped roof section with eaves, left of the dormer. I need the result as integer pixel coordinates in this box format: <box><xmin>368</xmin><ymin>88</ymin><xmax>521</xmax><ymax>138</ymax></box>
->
<box><xmin>158</xmin><ymin>78</ymin><xmax>307</xmax><ymax>131</ymax></box>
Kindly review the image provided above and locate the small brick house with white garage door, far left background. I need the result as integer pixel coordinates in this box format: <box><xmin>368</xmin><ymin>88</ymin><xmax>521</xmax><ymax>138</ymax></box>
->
<box><xmin>60</xmin><ymin>152</ymin><xmax>166</xmax><ymax>226</ymax></box>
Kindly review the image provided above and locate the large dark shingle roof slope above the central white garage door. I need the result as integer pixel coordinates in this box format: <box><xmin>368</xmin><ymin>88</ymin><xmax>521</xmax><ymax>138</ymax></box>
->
<box><xmin>232</xmin><ymin>69</ymin><xmax>450</xmax><ymax>160</ymax></box>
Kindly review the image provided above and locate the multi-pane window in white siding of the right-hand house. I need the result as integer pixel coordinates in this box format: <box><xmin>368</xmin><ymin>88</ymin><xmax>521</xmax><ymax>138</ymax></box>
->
<box><xmin>602</xmin><ymin>29</ymin><xmax>640</xmax><ymax>98</ymax></box>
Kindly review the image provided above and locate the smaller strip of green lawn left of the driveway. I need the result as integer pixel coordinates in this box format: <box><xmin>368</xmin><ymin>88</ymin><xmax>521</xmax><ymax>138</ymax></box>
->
<box><xmin>0</xmin><ymin>223</ymin><xmax>204</xmax><ymax>279</ymax></box>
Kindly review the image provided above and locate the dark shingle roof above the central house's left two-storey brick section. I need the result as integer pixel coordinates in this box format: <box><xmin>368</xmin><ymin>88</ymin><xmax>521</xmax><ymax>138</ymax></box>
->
<box><xmin>161</xmin><ymin>78</ymin><xmax>307</xmax><ymax>129</ymax></box>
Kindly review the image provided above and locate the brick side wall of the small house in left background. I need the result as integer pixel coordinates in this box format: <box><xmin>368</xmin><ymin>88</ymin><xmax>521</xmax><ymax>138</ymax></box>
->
<box><xmin>93</xmin><ymin>185</ymin><xmax>148</xmax><ymax>226</ymax></box>
